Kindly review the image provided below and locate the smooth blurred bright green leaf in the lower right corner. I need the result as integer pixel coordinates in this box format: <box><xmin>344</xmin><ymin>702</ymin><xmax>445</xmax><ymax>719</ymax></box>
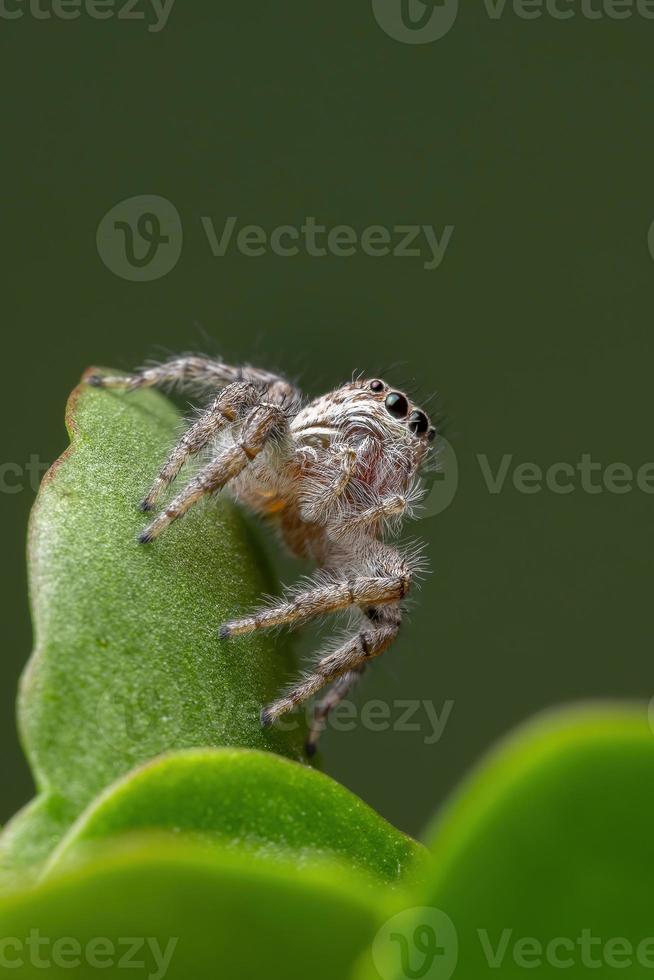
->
<box><xmin>355</xmin><ymin>705</ymin><xmax>654</xmax><ymax>980</ymax></box>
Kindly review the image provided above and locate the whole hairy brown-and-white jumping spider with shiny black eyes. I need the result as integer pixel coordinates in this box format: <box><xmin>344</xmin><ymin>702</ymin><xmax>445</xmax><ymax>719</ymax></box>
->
<box><xmin>87</xmin><ymin>356</ymin><xmax>436</xmax><ymax>754</ymax></box>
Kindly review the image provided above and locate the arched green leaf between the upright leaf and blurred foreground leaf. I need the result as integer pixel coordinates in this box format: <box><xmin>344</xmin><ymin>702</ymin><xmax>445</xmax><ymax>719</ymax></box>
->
<box><xmin>44</xmin><ymin>749</ymin><xmax>425</xmax><ymax>882</ymax></box>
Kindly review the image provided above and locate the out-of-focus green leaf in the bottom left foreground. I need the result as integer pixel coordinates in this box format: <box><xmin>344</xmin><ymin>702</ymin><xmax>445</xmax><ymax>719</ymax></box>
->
<box><xmin>0</xmin><ymin>835</ymin><xmax>384</xmax><ymax>980</ymax></box>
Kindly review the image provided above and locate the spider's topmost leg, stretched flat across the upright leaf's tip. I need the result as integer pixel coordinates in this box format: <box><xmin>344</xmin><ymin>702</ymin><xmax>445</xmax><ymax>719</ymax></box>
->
<box><xmin>85</xmin><ymin>356</ymin><xmax>293</xmax><ymax>391</ymax></box>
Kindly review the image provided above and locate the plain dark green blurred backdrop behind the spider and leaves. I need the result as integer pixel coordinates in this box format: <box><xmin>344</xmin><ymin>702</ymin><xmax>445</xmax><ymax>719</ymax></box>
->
<box><xmin>0</xmin><ymin>0</ymin><xmax>654</xmax><ymax>832</ymax></box>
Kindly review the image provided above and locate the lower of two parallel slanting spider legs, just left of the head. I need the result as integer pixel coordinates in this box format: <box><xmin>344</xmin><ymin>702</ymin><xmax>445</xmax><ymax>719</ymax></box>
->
<box><xmin>139</xmin><ymin>402</ymin><xmax>288</xmax><ymax>544</ymax></box>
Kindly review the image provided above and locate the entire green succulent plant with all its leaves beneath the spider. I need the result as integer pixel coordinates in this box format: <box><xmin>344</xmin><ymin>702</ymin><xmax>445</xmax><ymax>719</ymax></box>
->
<box><xmin>0</xmin><ymin>372</ymin><xmax>654</xmax><ymax>980</ymax></box>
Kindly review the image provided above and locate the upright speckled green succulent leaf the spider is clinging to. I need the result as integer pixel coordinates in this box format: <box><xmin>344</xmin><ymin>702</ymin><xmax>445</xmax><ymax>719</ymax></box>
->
<box><xmin>0</xmin><ymin>376</ymin><xmax>303</xmax><ymax>873</ymax></box>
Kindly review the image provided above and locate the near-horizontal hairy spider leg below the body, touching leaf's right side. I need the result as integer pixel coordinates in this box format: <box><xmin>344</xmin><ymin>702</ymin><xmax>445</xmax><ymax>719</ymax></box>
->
<box><xmin>220</xmin><ymin>570</ymin><xmax>411</xmax><ymax>640</ymax></box>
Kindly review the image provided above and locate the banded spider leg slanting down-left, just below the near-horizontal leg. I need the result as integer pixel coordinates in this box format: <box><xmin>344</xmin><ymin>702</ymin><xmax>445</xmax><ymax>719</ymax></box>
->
<box><xmin>261</xmin><ymin>620</ymin><xmax>401</xmax><ymax>728</ymax></box>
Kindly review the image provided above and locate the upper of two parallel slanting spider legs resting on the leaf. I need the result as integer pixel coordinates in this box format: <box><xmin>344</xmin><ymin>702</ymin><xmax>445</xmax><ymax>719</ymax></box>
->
<box><xmin>141</xmin><ymin>381</ymin><xmax>261</xmax><ymax>511</ymax></box>
